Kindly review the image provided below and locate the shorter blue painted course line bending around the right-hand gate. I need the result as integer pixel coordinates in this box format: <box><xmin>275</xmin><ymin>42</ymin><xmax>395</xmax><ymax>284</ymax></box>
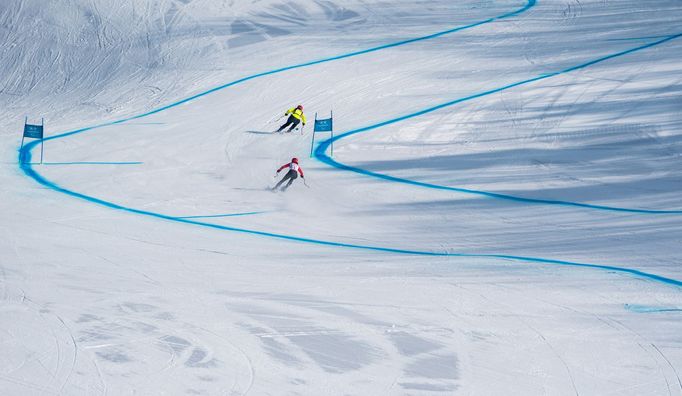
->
<box><xmin>315</xmin><ymin>33</ymin><xmax>682</xmax><ymax>214</ymax></box>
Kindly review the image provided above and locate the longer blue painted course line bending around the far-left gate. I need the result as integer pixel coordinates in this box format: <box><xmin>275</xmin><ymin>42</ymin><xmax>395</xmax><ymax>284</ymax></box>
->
<box><xmin>18</xmin><ymin>0</ymin><xmax>682</xmax><ymax>287</ymax></box>
